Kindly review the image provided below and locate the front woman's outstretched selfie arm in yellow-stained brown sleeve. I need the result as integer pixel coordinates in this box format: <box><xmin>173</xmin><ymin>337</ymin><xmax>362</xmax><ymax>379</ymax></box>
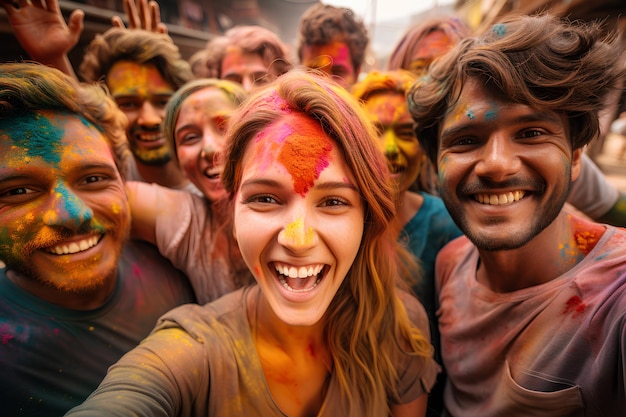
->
<box><xmin>66</xmin><ymin>327</ymin><xmax>204</xmax><ymax>417</ymax></box>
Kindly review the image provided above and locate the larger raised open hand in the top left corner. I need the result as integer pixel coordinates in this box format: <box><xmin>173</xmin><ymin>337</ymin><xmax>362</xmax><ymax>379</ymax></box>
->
<box><xmin>0</xmin><ymin>0</ymin><xmax>85</xmax><ymax>78</ymax></box>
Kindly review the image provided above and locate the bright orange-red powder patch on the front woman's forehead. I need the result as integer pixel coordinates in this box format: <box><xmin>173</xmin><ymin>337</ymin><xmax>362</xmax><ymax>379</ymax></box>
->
<box><xmin>277</xmin><ymin>119</ymin><xmax>333</xmax><ymax>197</ymax></box>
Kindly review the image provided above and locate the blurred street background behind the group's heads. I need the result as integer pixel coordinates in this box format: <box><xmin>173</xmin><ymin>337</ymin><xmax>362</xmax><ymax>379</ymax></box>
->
<box><xmin>0</xmin><ymin>0</ymin><xmax>626</xmax><ymax>190</ymax></box>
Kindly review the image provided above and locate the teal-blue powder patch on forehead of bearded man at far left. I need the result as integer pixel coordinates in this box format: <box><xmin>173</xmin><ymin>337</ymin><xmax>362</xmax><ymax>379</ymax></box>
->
<box><xmin>0</xmin><ymin>113</ymin><xmax>63</xmax><ymax>165</ymax></box>
